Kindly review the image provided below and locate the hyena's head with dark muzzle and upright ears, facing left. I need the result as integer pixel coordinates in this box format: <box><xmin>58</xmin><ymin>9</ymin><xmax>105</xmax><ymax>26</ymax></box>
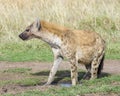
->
<box><xmin>19</xmin><ymin>19</ymin><xmax>41</xmax><ymax>40</ymax></box>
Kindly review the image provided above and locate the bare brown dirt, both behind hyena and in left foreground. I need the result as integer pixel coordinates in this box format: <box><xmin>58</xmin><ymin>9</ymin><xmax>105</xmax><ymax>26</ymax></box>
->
<box><xmin>0</xmin><ymin>60</ymin><xmax>120</xmax><ymax>96</ymax></box>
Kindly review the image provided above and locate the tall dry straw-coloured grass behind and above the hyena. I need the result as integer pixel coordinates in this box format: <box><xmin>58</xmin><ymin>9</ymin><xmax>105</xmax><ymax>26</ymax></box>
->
<box><xmin>0</xmin><ymin>0</ymin><xmax>120</xmax><ymax>60</ymax></box>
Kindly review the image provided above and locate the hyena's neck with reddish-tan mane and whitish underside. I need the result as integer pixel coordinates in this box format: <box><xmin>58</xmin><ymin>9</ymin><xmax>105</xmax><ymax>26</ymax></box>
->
<box><xmin>37</xmin><ymin>21</ymin><xmax>67</xmax><ymax>48</ymax></box>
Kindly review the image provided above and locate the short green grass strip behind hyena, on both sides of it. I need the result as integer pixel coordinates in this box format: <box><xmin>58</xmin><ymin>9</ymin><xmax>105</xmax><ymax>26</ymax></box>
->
<box><xmin>0</xmin><ymin>40</ymin><xmax>120</xmax><ymax>62</ymax></box>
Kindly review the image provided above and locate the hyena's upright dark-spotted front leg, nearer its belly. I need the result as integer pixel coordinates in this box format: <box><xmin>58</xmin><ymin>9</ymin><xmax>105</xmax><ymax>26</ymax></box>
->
<box><xmin>70</xmin><ymin>58</ymin><xmax>78</xmax><ymax>85</ymax></box>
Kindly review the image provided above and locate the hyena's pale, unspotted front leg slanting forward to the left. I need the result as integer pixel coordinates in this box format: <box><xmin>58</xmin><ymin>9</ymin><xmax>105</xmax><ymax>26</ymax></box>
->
<box><xmin>45</xmin><ymin>48</ymin><xmax>63</xmax><ymax>85</ymax></box>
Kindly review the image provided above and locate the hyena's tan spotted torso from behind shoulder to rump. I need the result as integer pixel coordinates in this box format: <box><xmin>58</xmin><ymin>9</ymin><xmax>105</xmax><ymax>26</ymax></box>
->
<box><xmin>67</xmin><ymin>30</ymin><xmax>105</xmax><ymax>64</ymax></box>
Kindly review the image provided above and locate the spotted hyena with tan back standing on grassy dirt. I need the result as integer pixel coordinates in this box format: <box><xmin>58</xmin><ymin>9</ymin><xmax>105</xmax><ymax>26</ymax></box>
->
<box><xmin>19</xmin><ymin>20</ymin><xmax>105</xmax><ymax>85</ymax></box>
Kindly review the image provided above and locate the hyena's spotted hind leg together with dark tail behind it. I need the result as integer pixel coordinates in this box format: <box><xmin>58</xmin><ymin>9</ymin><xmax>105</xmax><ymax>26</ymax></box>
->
<box><xmin>91</xmin><ymin>51</ymin><xmax>104</xmax><ymax>79</ymax></box>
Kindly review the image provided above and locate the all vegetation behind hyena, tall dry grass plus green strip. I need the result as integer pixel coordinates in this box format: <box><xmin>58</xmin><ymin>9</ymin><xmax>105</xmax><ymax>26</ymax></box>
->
<box><xmin>0</xmin><ymin>0</ymin><xmax>120</xmax><ymax>61</ymax></box>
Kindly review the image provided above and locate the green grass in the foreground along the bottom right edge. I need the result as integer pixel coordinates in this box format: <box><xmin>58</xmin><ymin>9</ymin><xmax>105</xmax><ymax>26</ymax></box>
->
<box><xmin>3</xmin><ymin>75</ymin><xmax>120</xmax><ymax>96</ymax></box>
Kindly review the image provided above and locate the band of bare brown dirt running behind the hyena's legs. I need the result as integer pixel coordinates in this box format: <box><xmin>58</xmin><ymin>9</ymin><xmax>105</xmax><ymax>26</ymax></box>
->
<box><xmin>0</xmin><ymin>60</ymin><xmax>120</xmax><ymax>75</ymax></box>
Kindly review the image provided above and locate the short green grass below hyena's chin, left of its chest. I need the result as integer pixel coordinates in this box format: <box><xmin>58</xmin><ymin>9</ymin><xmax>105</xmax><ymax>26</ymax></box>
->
<box><xmin>0</xmin><ymin>42</ymin><xmax>53</xmax><ymax>62</ymax></box>
